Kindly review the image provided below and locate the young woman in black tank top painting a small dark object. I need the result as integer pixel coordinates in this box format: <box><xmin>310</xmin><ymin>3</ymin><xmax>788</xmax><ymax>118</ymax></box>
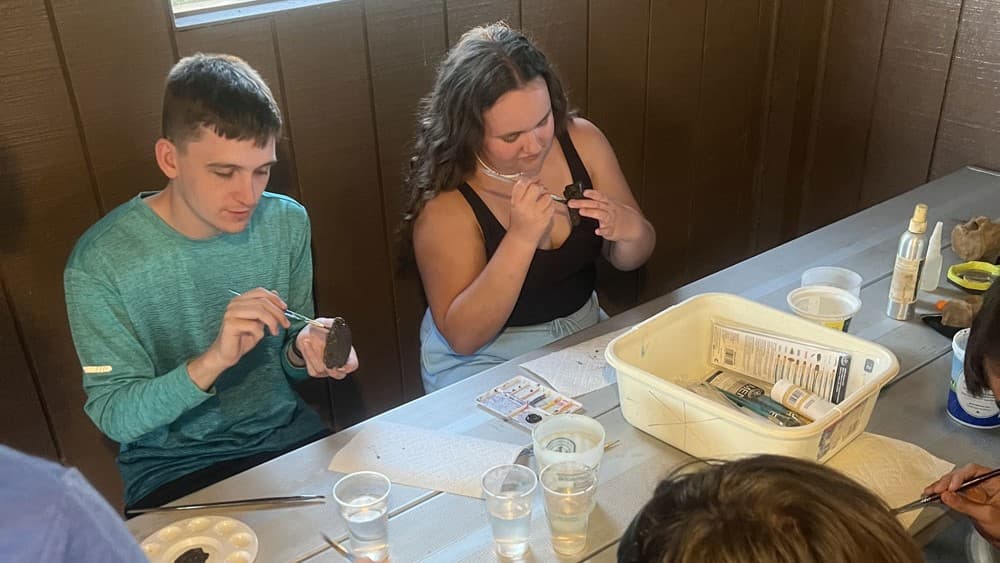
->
<box><xmin>402</xmin><ymin>20</ymin><xmax>655</xmax><ymax>391</ymax></box>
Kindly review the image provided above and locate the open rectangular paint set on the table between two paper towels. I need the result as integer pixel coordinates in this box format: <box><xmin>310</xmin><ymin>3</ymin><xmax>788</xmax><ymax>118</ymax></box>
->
<box><xmin>476</xmin><ymin>375</ymin><xmax>583</xmax><ymax>432</ymax></box>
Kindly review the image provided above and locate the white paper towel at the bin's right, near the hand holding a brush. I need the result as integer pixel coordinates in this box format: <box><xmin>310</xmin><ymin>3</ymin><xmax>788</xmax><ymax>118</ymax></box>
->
<box><xmin>826</xmin><ymin>432</ymin><xmax>955</xmax><ymax>528</ymax></box>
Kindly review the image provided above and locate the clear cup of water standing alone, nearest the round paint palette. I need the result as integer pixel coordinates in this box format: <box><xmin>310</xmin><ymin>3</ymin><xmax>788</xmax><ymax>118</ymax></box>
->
<box><xmin>333</xmin><ymin>471</ymin><xmax>392</xmax><ymax>561</ymax></box>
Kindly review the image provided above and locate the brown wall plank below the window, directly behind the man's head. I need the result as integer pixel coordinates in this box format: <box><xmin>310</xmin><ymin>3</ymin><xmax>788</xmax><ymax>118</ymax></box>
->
<box><xmin>174</xmin><ymin>18</ymin><xmax>301</xmax><ymax>199</ymax></box>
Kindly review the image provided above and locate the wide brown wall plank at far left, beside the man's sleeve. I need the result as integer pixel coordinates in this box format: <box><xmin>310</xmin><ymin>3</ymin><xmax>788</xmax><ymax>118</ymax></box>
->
<box><xmin>0</xmin><ymin>0</ymin><xmax>121</xmax><ymax>503</ymax></box>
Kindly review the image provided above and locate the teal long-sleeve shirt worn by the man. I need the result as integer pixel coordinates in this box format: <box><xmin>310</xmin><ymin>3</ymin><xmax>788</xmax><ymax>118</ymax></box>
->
<box><xmin>64</xmin><ymin>192</ymin><xmax>323</xmax><ymax>505</ymax></box>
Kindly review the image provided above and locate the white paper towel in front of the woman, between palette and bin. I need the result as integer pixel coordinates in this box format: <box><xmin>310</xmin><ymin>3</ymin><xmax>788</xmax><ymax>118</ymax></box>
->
<box><xmin>521</xmin><ymin>328</ymin><xmax>628</xmax><ymax>397</ymax></box>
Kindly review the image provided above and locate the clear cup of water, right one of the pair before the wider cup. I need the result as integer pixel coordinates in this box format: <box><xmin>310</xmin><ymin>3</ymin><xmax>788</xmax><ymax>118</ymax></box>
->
<box><xmin>540</xmin><ymin>461</ymin><xmax>597</xmax><ymax>555</ymax></box>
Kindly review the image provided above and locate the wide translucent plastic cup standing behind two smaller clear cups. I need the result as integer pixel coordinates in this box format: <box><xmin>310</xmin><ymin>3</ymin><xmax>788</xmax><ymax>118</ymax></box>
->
<box><xmin>531</xmin><ymin>414</ymin><xmax>604</xmax><ymax>471</ymax></box>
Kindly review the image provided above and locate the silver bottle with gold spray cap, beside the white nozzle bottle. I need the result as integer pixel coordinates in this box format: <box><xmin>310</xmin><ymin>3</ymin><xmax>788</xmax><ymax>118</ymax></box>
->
<box><xmin>885</xmin><ymin>203</ymin><xmax>927</xmax><ymax>321</ymax></box>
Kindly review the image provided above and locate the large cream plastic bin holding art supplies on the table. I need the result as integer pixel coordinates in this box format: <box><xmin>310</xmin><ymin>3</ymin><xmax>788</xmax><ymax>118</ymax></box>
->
<box><xmin>605</xmin><ymin>293</ymin><xmax>899</xmax><ymax>462</ymax></box>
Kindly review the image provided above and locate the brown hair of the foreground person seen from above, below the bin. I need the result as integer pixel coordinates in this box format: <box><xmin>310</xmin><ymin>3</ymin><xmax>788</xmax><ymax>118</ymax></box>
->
<box><xmin>618</xmin><ymin>455</ymin><xmax>923</xmax><ymax>563</ymax></box>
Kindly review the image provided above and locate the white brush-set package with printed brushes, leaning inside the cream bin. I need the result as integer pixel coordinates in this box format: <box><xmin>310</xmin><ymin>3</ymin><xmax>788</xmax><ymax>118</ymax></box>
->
<box><xmin>711</xmin><ymin>323</ymin><xmax>851</xmax><ymax>404</ymax></box>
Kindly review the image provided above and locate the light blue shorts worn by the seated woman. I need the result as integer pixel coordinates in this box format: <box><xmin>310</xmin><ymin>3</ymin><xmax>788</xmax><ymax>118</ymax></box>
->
<box><xmin>420</xmin><ymin>293</ymin><xmax>608</xmax><ymax>393</ymax></box>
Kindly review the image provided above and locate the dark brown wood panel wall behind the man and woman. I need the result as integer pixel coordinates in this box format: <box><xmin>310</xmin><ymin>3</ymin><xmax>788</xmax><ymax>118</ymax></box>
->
<box><xmin>0</xmin><ymin>0</ymin><xmax>1000</xmax><ymax>508</ymax></box>
